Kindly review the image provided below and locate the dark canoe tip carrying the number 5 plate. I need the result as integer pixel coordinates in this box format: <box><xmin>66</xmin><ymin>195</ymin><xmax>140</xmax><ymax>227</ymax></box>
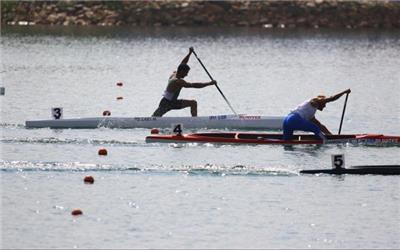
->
<box><xmin>300</xmin><ymin>165</ymin><xmax>400</xmax><ymax>175</ymax></box>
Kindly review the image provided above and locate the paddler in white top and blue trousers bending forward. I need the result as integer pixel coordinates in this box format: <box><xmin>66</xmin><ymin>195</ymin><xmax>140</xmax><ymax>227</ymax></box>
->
<box><xmin>283</xmin><ymin>89</ymin><xmax>351</xmax><ymax>142</ymax></box>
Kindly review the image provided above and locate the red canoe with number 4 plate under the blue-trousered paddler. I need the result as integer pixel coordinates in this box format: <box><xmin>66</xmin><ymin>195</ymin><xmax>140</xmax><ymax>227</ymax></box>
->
<box><xmin>146</xmin><ymin>132</ymin><xmax>400</xmax><ymax>145</ymax></box>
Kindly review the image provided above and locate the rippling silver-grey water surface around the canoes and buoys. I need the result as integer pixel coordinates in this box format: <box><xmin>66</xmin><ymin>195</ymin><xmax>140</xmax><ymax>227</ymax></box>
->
<box><xmin>0</xmin><ymin>27</ymin><xmax>400</xmax><ymax>248</ymax></box>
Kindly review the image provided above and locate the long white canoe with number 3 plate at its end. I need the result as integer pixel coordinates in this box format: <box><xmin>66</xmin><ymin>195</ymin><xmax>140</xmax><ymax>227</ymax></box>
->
<box><xmin>25</xmin><ymin>115</ymin><xmax>284</xmax><ymax>129</ymax></box>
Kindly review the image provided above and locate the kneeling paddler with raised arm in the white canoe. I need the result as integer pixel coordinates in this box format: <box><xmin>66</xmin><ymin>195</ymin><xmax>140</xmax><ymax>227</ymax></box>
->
<box><xmin>152</xmin><ymin>47</ymin><xmax>217</xmax><ymax>117</ymax></box>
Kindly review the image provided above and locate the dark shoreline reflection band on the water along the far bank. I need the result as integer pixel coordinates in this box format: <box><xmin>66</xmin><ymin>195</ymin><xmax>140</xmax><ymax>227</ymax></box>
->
<box><xmin>2</xmin><ymin>25</ymin><xmax>400</xmax><ymax>39</ymax></box>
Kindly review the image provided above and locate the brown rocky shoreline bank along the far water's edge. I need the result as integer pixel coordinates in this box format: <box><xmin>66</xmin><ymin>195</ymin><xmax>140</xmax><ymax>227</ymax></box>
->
<box><xmin>1</xmin><ymin>0</ymin><xmax>400</xmax><ymax>29</ymax></box>
